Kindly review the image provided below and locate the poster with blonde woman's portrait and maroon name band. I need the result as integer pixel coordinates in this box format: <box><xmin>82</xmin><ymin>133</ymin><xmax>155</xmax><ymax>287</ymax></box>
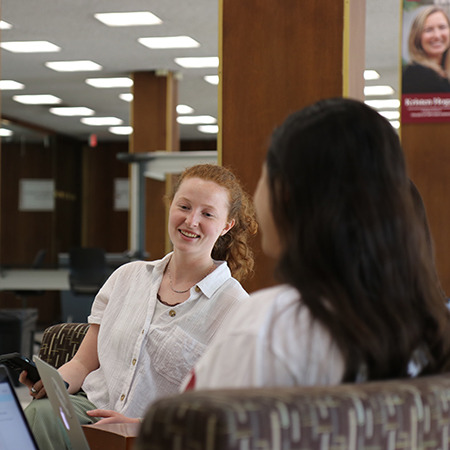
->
<box><xmin>401</xmin><ymin>0</ymin><xmax>450</xmax><ymax>123</ymax></box>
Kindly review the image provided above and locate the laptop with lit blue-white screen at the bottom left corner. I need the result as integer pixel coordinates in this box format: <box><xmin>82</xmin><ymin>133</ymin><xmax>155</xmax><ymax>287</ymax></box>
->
<box><xmin>0</xmin><ymin>365</ymin><xmax>39</xmax><ymax>450</ymax></box>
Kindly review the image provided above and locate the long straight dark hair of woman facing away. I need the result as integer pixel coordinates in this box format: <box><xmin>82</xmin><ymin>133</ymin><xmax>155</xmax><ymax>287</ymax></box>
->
<box><xmin>266</xmin><ymin>98</ymin><xmax>450</xmax><ymax>381</ymax></box>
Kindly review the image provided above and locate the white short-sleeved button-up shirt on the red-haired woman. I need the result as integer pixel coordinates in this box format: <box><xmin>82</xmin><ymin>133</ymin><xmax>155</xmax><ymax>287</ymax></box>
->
<box><xmin>83</xmin><ymin>254</ymin><xmax>248</xmax><ymax>417</ymax></box>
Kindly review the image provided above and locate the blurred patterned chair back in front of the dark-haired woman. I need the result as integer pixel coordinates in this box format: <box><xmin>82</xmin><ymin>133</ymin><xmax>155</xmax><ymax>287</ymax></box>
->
<box><xmin>135</xmin><ymin>374</ymin><xmax>450</xmax><ymax>450</ymax></box>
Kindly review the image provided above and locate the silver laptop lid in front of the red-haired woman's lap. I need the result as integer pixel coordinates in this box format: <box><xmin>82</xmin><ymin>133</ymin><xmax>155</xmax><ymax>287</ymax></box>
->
<box><xmin>33</xmin><ymin>355</ymin><xmax>89</xmax><ymax>450</ymax></box>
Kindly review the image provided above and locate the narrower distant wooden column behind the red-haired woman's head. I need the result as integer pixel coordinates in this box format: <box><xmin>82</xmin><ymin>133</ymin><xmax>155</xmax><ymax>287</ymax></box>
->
<box><xmin>129</xmin><ymin>72</ymin><xmax>180</xmax><ymax>259</ymax></box>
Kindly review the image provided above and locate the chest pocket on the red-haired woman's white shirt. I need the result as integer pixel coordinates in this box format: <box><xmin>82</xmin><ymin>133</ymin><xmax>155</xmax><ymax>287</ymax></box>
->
<box><xmin>150</xmin><ymin>326</ymin><xmax>206</xmax><ymax>384</ymax></box>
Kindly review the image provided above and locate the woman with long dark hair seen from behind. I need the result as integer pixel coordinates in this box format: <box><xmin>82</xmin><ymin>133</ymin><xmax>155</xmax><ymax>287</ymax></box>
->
<box><xmin>185</xmin><ymin>98</ymin><xmax>450</xmax><ymax>389</ymax></box>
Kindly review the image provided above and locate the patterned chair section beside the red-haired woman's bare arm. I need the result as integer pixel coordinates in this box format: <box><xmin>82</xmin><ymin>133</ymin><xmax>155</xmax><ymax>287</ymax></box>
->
<box><xmin>39</xmin><ymin>323</ymin><xmax>89</xmax><ymax>368</ymax></box>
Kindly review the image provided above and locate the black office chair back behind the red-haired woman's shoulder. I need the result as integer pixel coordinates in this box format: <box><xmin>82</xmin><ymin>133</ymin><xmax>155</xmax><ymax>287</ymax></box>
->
<box><xmin>69</xmin><ymin>247</ymin><xmax>108</xmax><ymax>295</ymax></box>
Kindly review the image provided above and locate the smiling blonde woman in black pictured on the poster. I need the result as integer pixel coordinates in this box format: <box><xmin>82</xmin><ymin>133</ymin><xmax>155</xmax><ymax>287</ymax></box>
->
<box><xmin>402</xmin><ymin>5</ymin><xmax>450</xmax><ymax>94</ymax></box>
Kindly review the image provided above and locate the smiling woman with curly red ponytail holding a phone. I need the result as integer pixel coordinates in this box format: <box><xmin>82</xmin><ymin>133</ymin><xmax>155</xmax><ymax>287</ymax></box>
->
<box><xmin>21</xmin><ymin>164</ymin><xmax>257</xmax><ymax>449</ymax></box>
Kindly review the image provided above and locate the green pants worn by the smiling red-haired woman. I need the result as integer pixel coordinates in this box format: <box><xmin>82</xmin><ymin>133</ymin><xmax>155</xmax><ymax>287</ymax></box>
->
<box><xmin>25</xmin><ymin>391</ymin><xmax>99</xmax><ymax>450</ymax></box>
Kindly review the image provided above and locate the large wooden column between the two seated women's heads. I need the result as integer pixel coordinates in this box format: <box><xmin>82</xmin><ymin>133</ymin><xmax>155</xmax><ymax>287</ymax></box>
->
<box><xmin>218</xmin><ymin>0</ymin><xmax>365</xmax><ymax>291</ymax></box>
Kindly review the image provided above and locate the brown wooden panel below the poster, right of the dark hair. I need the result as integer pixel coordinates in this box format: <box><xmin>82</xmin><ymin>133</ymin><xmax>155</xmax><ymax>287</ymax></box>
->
<box><xmin>401</xmin><ymin>123</ymin><xmax>450</xmax><ymax>296</ymax></box>
